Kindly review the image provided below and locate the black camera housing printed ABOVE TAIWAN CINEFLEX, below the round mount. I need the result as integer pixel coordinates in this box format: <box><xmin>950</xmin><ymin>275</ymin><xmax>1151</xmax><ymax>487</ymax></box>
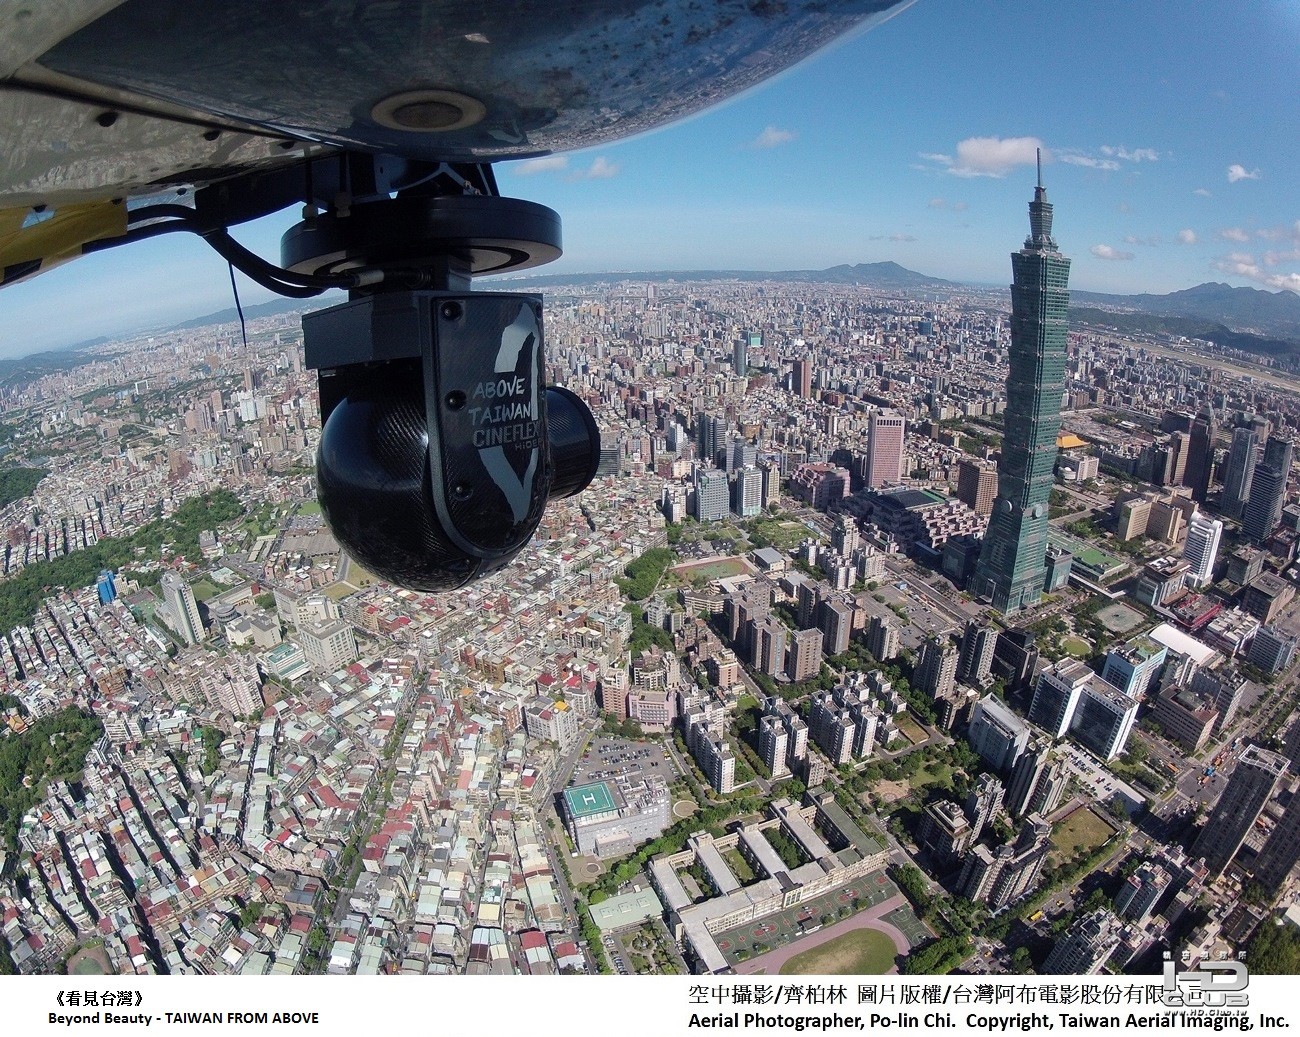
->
<box><xmin>303</xmin><ymin>291</ymin><xmax>601</xmax><ymax>591</ymax></box>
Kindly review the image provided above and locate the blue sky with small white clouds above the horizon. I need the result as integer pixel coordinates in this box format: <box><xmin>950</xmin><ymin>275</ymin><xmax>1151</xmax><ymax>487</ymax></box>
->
<box><xmin>0</xmin><ymin>0</ymin><xmax>1300</xmax><ymax>355</ymax></box>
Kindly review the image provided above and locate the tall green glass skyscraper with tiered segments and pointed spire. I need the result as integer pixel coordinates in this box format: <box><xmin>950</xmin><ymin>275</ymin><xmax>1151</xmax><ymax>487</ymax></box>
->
<box><xmin>972</xmin><ymin>153</ymin><xmax>1070</xmax><ymax>613</ymax></box>
